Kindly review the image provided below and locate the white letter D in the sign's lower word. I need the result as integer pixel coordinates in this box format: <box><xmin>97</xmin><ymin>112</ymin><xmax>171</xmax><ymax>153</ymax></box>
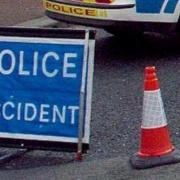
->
<box><xmin>24</xmin><ymin>103</ymin><xmax>37</xmax><ymax>121</ymax></box>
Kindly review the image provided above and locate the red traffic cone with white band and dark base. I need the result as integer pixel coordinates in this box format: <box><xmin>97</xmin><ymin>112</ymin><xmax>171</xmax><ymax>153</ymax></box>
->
<box><xmin>130</xmin><ymin>67</ymin><xmax>180</xmax><ymax>169</ymax></box>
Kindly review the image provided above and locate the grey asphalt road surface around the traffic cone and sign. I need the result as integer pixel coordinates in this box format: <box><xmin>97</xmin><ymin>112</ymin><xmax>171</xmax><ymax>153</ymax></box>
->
<box><xmin>0</xmin><ymin>0</ymin><xmax>180</xmax><ymax>180</ymax></box>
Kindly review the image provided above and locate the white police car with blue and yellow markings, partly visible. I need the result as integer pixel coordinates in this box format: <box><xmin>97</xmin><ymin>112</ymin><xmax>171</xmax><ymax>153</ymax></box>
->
<box><xmin>43</xmin><ymin>0</ymin><xmax>180</xmax><ymax>34</ymax></box>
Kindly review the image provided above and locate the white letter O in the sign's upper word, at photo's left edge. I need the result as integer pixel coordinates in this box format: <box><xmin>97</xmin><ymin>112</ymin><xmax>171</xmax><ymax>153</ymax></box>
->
<box><xmin>0</xmin><ymin>49</ymin><xmax>16</xmax><ymax>75</ymax></box>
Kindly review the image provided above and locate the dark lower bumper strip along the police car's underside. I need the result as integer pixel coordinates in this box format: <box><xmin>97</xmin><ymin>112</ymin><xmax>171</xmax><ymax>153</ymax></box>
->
<box><xmin>46</xmin><ymin>11</ymin><xmax>177</xmax><ymax>34</ymax></box>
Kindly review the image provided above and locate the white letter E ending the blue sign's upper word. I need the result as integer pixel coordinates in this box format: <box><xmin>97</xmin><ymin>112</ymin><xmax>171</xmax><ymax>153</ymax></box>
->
<box><xmin>63</xmin><ymin>53</ymin><xmax>77</xmax><ymax>78</ymax></box>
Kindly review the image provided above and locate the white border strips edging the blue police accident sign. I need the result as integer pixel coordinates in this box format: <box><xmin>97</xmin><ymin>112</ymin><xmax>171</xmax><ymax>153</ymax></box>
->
<box><xmin>0</xmin><ymin>36</ymin><xmax>95</xmax><ymax>144</ymax></box>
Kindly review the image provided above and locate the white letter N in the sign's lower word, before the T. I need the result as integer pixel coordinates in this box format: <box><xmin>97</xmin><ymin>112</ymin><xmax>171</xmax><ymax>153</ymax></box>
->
<box><xmin>52</xmin><ymin>105</ymin><xmax>66</xmax><ymax>123</ymax></box>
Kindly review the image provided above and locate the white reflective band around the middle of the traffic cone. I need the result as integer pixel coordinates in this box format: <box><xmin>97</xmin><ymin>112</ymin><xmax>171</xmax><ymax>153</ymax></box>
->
<box><xmin>141</xmin><ymin>89</ymin><xmax>167</xmax><ymax>129</ymax></box>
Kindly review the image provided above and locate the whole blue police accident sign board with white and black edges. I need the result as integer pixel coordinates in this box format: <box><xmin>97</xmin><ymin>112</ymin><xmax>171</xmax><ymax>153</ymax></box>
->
<box><xmin>0</xmin><ymin>28</ymin><xmax>95</xmax><ymax>151</ymax></box>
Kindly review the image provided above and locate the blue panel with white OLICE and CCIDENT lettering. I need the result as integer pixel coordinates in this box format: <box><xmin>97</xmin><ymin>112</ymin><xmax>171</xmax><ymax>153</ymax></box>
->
<box><xmin>0</xmin><ymin>37</ymin><xmax>85</xmax><ymax>138</ymax></box>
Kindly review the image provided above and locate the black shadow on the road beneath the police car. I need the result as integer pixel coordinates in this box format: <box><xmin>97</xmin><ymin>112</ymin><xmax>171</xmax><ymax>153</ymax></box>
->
<box><xmin>96</xmin><ymin>33</ymin><xmax>180</xmax><ymax>61</ymax></box>
